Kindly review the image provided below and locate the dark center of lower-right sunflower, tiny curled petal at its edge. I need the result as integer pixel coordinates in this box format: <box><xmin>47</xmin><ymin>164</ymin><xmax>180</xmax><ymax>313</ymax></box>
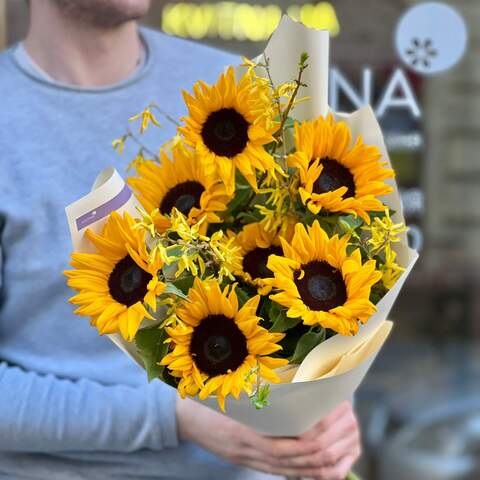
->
<box><xmin>294</xmin><ymin>262</ymin><xmax>347</xmax><ymax>312</ymax></box>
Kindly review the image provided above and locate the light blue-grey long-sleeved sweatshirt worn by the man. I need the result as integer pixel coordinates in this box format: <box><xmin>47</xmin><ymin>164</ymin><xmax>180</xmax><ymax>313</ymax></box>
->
<box><xmin>0</xmin><ymin>30</ymin><xmax>273</xmax><ymax>480</ymax></box>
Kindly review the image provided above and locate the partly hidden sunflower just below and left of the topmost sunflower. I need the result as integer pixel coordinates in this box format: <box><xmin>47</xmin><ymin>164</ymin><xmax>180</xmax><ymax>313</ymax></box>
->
<box><xmin>128</xmin><ymin>143</ymin><xmax>230</xmax><ymax>232</ymax></box>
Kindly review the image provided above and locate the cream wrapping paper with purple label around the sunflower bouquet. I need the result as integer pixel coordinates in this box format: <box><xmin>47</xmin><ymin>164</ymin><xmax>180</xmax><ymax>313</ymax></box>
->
<box><xmin>66</xmin><ymin>17</ymin><xmax>418</xmax><ymax>436</ymax></box>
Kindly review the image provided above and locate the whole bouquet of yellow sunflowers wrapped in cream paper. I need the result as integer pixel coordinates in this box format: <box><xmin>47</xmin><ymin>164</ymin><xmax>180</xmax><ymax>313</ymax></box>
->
<box><xmin>65</xmin><ymin>19</ymin><xmax>416</xmax><ymax>435</ymax></box>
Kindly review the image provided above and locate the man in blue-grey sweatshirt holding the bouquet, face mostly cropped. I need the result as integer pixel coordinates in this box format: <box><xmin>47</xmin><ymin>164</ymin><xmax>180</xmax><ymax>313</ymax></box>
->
<box><xmin>0</xmin><ymin>0</ymin><xmax>360</xmax><ymax>480</ymax></box>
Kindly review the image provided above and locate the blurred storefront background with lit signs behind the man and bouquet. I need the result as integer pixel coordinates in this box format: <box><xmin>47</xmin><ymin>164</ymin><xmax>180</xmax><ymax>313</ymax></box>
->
<box><xmin>0</xmin><ymin>0</ymin><xmax>480</xmax><ymax>480</ymax></box>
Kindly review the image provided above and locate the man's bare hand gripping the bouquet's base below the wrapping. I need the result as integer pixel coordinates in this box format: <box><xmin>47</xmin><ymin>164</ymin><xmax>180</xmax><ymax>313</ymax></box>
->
<box><xmin>177</xmin><ymin>399</ymin><xmax>361</xmax><ymax>480</ymax></box>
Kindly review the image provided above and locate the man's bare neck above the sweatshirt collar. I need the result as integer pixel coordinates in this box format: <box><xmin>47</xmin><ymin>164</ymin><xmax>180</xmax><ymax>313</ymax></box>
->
<box><xmin>25</xmin><ymin>2</ymin><xmax>142</xmax><ymax>87</ymax></box>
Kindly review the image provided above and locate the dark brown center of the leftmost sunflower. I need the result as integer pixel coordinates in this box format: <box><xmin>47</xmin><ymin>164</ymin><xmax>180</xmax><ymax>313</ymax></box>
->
<box><xmin>108</xmin><ymin>255</ymin><xmax>152</xmax><ymax>307</ymax></box>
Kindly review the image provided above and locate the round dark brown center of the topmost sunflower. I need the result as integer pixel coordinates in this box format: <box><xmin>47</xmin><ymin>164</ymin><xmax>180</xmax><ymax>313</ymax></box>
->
<box><xmin>202</xmin><ymin>108</ymin><xmax>249</xmax><ymax>158</ymax></box>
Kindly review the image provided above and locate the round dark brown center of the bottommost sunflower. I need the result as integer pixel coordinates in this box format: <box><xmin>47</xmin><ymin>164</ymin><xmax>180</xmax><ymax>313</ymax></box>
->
<box><xmin>190</xmin><ymin>315</ymin><xmax>248</xmax><ymax>377</ymax></box>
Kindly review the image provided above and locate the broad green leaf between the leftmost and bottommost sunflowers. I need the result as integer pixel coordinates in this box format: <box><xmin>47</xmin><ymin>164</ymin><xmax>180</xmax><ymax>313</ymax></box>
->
<box><xmin>134</xmin><ymin>326</ymin><xmax>168</xmax><ymax>382</ymax></box>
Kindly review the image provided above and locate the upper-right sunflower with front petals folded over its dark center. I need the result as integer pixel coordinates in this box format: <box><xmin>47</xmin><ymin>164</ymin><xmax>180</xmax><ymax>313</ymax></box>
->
<box><xmin>289</xmin><ymin>115</ymin><xmax>394</xmax><ymax>223</ymax></box>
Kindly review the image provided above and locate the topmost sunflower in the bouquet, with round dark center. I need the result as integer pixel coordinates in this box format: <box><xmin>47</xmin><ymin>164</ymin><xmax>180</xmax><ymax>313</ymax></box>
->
<box><xmin>179</xmin><ymin>67</ymin><xmax>278</xmax><ymax>193</ymax></box>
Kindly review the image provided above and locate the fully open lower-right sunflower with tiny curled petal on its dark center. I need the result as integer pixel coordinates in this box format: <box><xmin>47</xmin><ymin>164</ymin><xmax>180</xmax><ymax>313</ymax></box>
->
<box><xmin>268</xmin><ymin>221</ymin><xmax>382</xmax><ymax>335</ymax></box>
